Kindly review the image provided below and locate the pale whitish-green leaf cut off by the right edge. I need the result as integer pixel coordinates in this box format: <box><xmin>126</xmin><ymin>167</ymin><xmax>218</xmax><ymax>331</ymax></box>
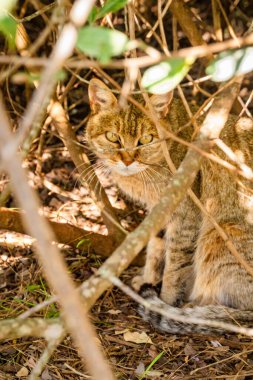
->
<box><xmin>206</xmin><ymin>47</ymin><xmax>253</xmax><ymax>82</ymax></box>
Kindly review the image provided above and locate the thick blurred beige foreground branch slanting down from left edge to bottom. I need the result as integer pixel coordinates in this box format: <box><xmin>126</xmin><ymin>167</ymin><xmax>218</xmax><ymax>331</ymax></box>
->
<box><xmin>0</xmin><ymin>95</ymin><xmax>114</xmax><ymax>380</ymax></box>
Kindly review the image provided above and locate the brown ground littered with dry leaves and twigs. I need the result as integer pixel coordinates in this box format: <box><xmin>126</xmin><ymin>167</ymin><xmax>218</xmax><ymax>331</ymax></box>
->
<box><xmin>0</xmin><ymin>141</ymin><xmax>253</xmax><ymax>380</ymax></box>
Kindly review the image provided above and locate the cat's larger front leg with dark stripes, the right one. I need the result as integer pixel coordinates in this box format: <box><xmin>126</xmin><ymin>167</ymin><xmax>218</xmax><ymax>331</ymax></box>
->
<box><xmin>161</xmin><ymin>197</ymin><xmax>200</xmax><ymax>306</ymax></box>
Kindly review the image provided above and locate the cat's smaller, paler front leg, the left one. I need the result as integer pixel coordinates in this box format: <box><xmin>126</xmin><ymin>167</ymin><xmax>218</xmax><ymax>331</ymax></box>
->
<box><xmin>132</xmin><ymin>236</ymin><xmax>165</xmax><ymax>291</ymax></box>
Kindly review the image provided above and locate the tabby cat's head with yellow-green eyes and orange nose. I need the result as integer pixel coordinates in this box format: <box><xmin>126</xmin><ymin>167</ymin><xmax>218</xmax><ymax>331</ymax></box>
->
<box><xmin>86</xmin><ymin>78</ymin><xmax>172</xmax><ymax>176</ymax></box>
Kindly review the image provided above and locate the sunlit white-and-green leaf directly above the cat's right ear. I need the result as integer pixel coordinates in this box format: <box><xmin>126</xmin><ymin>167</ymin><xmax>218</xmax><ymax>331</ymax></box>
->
<box><xmin>142</xmin><ymin>58</ymin><xmax>194</xmax><ymax>94</ymax></box>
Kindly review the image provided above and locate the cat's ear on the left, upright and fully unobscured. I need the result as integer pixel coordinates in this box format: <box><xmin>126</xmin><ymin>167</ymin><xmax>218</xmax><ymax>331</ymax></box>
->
<box><xmin>88</xmin><ymin>78</ymin><xmax>117</xmax><ymax>113</ymax></box>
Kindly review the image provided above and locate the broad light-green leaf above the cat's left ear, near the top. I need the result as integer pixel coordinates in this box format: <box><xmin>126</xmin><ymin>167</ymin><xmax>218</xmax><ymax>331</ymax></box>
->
<box><xmin>77</xmin><ymin>26</ymin><xmax>128</xmax><ymax>63</ymax></box>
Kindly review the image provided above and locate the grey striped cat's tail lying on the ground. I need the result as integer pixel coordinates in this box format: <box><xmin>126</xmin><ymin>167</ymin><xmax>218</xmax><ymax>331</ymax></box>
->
<box><xmin>139</xmin><ymin>286</ymin><xmax>253</xmax><ymax>335</ymax></box>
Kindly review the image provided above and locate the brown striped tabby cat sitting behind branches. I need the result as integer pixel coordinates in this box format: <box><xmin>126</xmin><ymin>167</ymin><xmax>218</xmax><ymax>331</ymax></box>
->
<box><xmin>86</xmin><ymin>78</ymin><xmax>253</xmax><ymax>334</ymax></box>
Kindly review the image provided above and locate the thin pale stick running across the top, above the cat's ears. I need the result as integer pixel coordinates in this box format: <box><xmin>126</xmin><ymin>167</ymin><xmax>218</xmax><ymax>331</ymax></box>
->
<box><xmin>0</xmin><ymin>33</ymin><xmax>253</xmax><ymax>69</ymax></box>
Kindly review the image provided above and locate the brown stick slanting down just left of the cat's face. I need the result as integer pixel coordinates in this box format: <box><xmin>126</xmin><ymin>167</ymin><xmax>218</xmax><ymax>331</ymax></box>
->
<box><xmin>50</xmin><ymin>101</ymin><xmax>126</xmax><ymax>239</ymax></box>
